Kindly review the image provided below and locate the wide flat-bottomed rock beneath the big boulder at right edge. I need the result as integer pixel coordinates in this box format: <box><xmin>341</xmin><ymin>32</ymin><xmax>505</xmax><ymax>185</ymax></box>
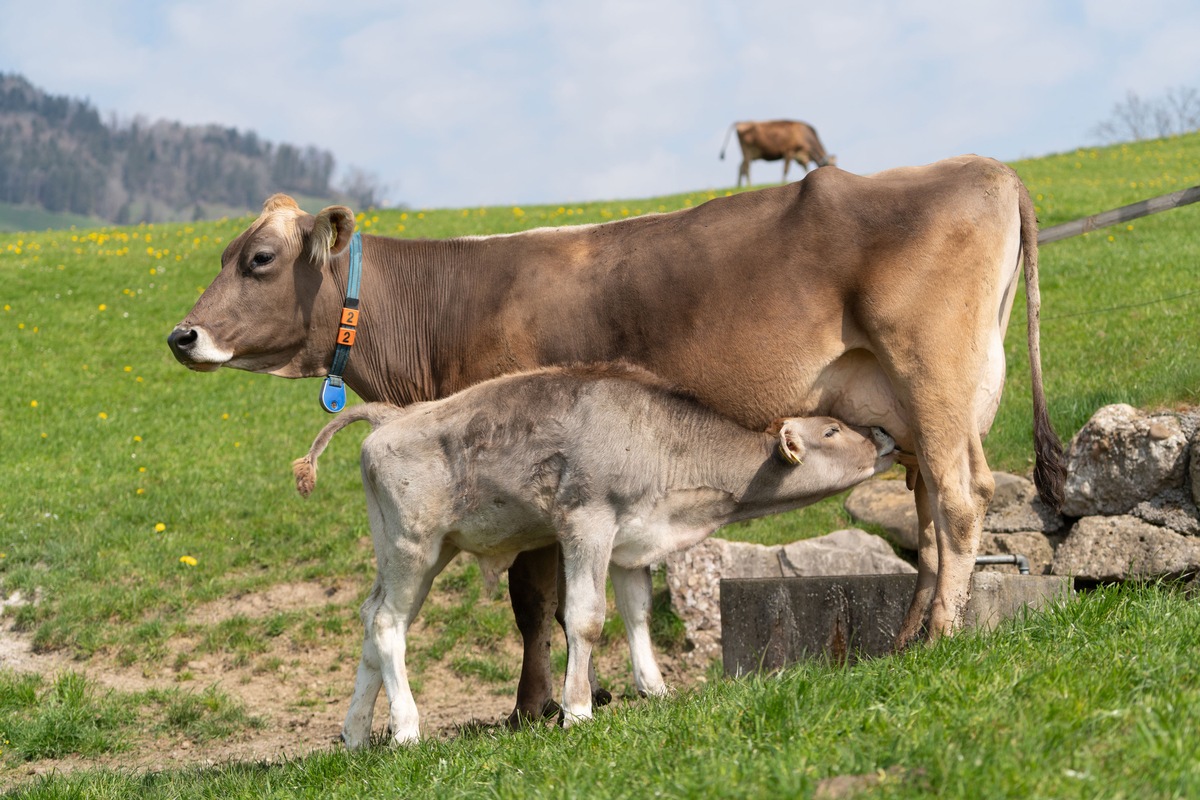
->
<box><xmin>1052</xmin><ymin>515</ymin><xmax>1200</xmax><ymax>581</ymax></box>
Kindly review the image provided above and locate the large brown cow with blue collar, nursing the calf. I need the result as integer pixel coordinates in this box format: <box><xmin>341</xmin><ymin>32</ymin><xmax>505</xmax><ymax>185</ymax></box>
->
<box><xmin>169</xmin><ymin>156</ymin><xmax>1063</xmax><ymax>734</ymax></box>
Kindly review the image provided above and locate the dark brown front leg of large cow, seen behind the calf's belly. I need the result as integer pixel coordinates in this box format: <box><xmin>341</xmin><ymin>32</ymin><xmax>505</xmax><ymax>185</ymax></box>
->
<box><xmin>509</xmin><ymin>545</ymin><xmax>559</xmax><ymax>728</ymax></box>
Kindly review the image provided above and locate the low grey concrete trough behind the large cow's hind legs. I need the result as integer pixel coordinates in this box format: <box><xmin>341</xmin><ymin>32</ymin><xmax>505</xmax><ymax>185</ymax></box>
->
<box><xmin>721</xmin><ymin>572</ymin><xmax>1072</xmax><ymax>675</ymax></box>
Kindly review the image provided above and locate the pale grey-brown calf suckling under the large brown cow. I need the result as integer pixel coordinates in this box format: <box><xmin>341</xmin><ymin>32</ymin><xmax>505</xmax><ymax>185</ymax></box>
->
<box><xmin>293</xmin><ymin>363</ymin><xmax>896</xmax><ymax>748</ymax></box>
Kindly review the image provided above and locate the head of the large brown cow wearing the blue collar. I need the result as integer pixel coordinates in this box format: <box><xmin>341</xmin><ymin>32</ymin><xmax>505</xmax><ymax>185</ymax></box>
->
<box><xmin>167</xmin><ymin>194</ymin><xmax>354</xmax><ymax>378</ymax></box>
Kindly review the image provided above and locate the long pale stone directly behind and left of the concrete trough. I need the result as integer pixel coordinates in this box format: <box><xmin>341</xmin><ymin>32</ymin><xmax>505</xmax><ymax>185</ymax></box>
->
<box><xmin>666</xmin><ymin>529</ymin><xmax>916</xmax><ymax>664</ymax></box>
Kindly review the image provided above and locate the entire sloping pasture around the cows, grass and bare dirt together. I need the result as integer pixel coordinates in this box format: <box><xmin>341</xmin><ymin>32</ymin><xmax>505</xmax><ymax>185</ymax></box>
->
<box><xmin>0</xmin><ymin>134</ymin><xmax>1200</xmax><ymax>798</ymax></box>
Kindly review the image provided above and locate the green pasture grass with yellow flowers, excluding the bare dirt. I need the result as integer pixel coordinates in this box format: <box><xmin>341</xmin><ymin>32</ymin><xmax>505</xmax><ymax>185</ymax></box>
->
<box><xmin>0</xmin><ymin>134</ymin><xmax>1200</xmax><ymax>796</ymax></box>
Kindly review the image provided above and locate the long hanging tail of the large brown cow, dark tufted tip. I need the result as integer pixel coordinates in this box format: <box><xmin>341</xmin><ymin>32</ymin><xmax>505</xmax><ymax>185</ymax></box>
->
<box><xmin>1018</xmin><ymin>182</ymin><xmax>1067</xmax><ymax>511</ymax></box>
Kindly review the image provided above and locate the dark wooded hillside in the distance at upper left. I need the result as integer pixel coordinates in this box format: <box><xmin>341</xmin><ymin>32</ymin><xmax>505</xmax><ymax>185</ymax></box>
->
<box><xmin>0</xmin><ymin>73</ymin><xmax>382</xmax><ymax>224</ymax></box>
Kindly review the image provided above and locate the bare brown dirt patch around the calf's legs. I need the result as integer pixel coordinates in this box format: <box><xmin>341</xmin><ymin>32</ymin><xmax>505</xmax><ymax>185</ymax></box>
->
<box><xmin>0</xmin><ymin>583</ymin><xmax>702</xmax><ymax>787</ymax></box>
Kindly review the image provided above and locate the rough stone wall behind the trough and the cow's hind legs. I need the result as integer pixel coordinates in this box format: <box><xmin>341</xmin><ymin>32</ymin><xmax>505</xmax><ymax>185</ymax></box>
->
<box><xmin>666</xmin><ymin>405</ymin><xmax>1200</xmax><ymax>664</ymax></box>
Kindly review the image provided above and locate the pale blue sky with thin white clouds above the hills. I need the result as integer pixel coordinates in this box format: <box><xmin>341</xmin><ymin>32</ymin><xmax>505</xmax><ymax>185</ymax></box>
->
<box><xmin>0</xmin><ymin>0</ymin><xmax>1200</xmax><ymax>209</ymax></box>
